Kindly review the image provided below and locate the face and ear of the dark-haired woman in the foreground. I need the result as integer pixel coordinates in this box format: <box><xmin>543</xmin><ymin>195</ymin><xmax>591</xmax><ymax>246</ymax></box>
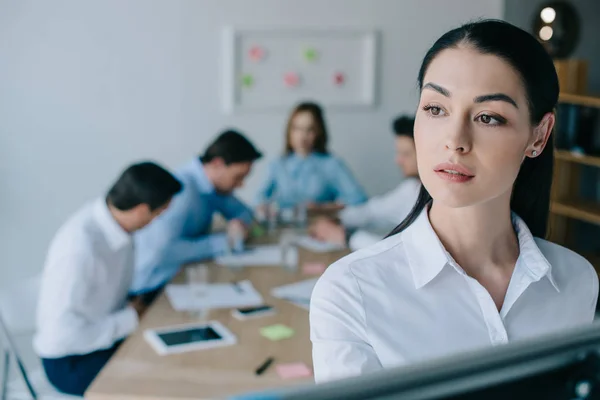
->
<box><xmin>415</xmin><ymin>46</ymin><xmax>554</xmax><ymax>208</ymax></box>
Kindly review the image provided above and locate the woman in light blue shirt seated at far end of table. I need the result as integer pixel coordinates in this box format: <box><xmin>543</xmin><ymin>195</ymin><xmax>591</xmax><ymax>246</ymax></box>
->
<box><xmin>257</xmin><ymin>103</ymin><xmax>367</xmax><ymax>209</ymax></box>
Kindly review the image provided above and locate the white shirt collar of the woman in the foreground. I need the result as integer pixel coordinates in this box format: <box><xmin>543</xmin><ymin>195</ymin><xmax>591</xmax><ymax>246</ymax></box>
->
<box><xmin>402</xmin><ymin>207</ymin><xmax>559</xmax><ymax>291</ymax></box>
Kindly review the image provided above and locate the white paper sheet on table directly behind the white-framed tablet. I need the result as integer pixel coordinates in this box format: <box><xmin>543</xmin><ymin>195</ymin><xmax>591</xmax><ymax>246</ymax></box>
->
<box><xmin>165</xmin><ymin>281</ymin><xmax>264</xmax><ymax>311</ymax></box>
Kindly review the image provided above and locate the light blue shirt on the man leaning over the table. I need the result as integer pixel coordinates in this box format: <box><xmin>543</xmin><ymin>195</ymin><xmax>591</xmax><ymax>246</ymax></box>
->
<box><xmin>131</xmin><ymin>158</ymin><xmax>252</xmax><ymax>294</ymax></box>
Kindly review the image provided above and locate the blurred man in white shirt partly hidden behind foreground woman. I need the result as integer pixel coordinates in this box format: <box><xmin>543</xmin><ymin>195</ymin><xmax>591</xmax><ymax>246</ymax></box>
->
<box><xmin>309</xmin><ymin>116</ymin><xmax>421</xmax><ymax>250</ymax></box>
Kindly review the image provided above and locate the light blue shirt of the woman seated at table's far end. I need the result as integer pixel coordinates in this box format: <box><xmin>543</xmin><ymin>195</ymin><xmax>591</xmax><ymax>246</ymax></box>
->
<box><xmin>256</xmin><ymin>153</ymin><xmax>367</xmax><ymax>207</ymax></box>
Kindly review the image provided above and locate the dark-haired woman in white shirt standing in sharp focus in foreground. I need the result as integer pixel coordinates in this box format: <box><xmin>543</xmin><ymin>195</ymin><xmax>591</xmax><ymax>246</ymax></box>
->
<box><xmin>310</xmin><ymin>20</ymin><xmax>598</xmax><ymax>382</ymax></box>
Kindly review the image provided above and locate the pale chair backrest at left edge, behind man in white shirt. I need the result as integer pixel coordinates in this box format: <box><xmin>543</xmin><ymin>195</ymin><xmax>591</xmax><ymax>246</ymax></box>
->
<box><xmin>0</xmin><ymin>274</ymin><xmax>41</xmax><ymax>335</ymax></box>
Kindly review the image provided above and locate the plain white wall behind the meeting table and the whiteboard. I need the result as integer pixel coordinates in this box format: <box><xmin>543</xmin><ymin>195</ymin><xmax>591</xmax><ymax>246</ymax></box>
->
<box><xmin>0</xmin><ymin>0</ymin><xmax>504</xmax><ymax>285</ymax></box>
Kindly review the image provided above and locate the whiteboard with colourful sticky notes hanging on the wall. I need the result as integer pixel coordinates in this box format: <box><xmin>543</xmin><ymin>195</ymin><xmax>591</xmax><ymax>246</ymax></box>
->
<box><xmin>223</xmin><ymin>27</ymin><xmax>377</xmax><ymax>112</ymax></box>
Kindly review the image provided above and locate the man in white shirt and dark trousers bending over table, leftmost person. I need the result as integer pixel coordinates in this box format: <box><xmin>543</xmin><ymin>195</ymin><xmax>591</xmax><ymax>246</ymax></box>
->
<box><xmin>34</xmin><ymin>162</ymin><xmax>182</xmax><ymax>395</ymax></box>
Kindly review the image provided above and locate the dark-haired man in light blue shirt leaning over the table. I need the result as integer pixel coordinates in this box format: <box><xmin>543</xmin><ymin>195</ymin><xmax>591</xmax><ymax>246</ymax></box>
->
<box><xmin>131</xmin><ymin>130</ymin><xmax>262</xmax><ymax>296</ymax></box>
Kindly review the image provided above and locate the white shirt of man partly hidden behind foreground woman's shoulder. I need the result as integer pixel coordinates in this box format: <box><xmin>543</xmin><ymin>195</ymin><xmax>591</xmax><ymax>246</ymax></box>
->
<box><xmin>340</xmin><ymin>177</ymin><xmax>421</xmax><ymax>250</ymax></box>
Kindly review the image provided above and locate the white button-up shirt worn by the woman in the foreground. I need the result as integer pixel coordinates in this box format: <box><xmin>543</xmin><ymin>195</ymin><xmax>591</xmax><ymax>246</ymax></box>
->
<box><xmin>310</xmin><ymin>210</ymin><xmax>598</xmax><ymax>382</ymax></box>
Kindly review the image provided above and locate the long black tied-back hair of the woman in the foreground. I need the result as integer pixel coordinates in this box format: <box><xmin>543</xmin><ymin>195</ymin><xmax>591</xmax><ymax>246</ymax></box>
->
<box><xmin>388</xmin><ymin>20</ymin><xmax>559</xmax><ymax>238</ymax></box>
